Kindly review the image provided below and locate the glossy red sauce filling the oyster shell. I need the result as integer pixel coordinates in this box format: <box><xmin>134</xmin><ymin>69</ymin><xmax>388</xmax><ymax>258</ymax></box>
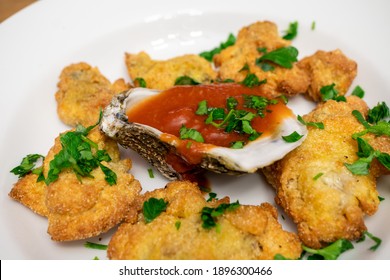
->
<box><xmin>127</xmin><ymin>84</ymin><xmax>292</xmax><ymax>164</ymax></box>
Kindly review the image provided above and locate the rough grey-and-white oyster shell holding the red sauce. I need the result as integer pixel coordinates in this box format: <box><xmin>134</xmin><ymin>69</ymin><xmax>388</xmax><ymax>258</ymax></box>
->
<box><xmin>100</xmin><ymin>88</ymin><xmax>307</xmax><ymax>180</ymax></box>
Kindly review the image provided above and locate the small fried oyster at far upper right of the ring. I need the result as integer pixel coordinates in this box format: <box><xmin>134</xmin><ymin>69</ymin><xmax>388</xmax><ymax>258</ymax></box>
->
<box><xmin>297</xmin><ymin>49</ymin><xmax>357</xmax><ymax>101</ymax></box>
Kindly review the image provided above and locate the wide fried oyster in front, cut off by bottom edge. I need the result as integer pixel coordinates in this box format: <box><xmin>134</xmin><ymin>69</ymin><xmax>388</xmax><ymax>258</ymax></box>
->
<box><xmin>108</xmin><ymin>181</ymin><xmax>301</xmax><ymax>259</ymax></box>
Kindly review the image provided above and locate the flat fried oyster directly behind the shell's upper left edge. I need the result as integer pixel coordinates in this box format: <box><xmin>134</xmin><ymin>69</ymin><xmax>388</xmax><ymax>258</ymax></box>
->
<box><xmin>125</xmin><ymin>52</ymin><xmax>216</xmax><ymax>90</ymax></box>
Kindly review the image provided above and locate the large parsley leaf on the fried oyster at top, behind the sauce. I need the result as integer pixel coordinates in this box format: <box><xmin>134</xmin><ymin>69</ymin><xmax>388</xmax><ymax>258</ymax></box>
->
<box><xmin>256</xmin><ymin>46</ymin><xmax>298</xmax><ymax>70</ymax></box>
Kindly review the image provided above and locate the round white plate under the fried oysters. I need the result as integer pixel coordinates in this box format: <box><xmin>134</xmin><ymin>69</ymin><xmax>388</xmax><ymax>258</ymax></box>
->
<box><xmin>0</xmin><ymin>0</ymin><xmax>390</xmax><ymax>259</ymax></box>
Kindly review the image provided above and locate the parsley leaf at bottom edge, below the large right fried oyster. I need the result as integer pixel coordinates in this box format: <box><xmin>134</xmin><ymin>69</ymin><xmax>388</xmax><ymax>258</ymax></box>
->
<box><xmin>302</xmin><ymin>239</ymin><xmax>354</xmax><ymax>260</ymax></box>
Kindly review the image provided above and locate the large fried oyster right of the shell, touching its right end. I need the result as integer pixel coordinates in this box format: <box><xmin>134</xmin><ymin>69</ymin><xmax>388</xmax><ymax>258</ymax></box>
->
<box><xmin>263</xmin><ymin>96</ymin><xmax>379</xmax><ymax>248</ymax></box>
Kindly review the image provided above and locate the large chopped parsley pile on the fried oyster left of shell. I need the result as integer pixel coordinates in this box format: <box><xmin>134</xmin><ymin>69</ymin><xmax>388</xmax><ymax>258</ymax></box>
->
<box><xmin>45</xmin><ymin>113</ymin><xmax>117</xmax><ymax>186</ymax></box>
